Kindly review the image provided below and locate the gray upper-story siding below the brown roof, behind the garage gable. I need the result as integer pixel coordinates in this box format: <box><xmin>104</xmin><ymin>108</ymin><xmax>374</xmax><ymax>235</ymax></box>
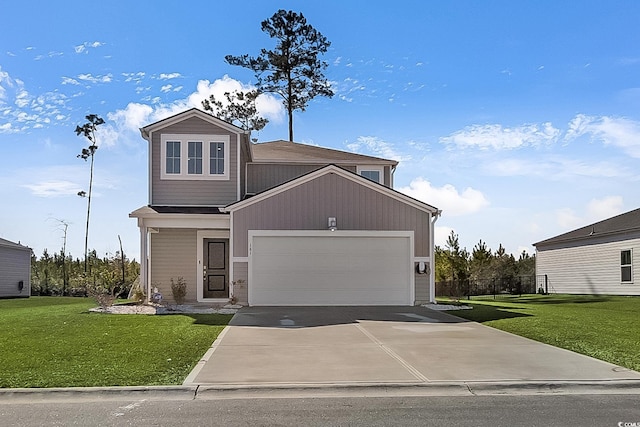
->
<box><xmin>247</xmin><ymin>163</ymin><xmax>356</xmax><ymax>194</ymax></box>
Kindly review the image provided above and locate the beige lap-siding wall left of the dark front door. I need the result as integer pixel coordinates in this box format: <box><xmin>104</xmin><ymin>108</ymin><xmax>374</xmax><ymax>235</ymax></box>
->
<box><xmin>151</xmin><ymin>228</ymin><xmax>198</xmax><ymax>304</ymax></box>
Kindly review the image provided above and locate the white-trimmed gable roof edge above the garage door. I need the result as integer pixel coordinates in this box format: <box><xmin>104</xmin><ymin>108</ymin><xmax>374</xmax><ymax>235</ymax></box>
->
<box><xmin>221</xmin><ymin>166</ymin><xmax>442</xmax><ymax>216</ymax></box>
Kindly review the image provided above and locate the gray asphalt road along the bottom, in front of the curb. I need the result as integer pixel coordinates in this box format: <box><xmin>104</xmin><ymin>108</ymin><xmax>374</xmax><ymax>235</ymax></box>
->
<box><xmin>0</xmin><ymin>394</ymin><xmax>640</xmax><ymax>427</ymax></box>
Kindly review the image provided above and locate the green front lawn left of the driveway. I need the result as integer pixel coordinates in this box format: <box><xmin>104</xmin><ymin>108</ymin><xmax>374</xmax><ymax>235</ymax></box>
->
<box><xmin>0</xmin><ymin>297</ymin><xmax>232</xmax><ymax>387</ymax></box>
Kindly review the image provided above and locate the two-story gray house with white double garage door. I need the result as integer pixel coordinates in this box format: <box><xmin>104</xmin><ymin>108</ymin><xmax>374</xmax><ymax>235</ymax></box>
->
<box><xmin>129</xmin><ymin>109</ymin><xmax>440</xmax><ymax>305</ymax></box>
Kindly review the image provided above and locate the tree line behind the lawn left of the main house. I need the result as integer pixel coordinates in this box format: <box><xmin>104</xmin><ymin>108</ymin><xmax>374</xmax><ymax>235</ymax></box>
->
<box><xmin>31</xmin><ymin>249</ymin><xmax>140</xmax><ymax>297</ymax></box>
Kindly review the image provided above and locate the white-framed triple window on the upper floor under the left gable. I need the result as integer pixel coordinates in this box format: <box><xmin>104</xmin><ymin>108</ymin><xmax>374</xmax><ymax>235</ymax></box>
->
<box><xmin>160</xmin><ymin>134</ymin><xmax>230</xmax><ymax>180</ymax></box>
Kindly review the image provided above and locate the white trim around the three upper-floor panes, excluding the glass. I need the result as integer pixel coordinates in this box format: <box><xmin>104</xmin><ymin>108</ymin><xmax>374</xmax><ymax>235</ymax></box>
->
<box><xmin>160</xmin><ymin>133</ymin><xmax>231</xmax><ymax>181</ymax></box>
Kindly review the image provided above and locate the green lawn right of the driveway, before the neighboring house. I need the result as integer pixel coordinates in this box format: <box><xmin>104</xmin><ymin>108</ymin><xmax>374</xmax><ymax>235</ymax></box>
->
<box><xmin>443</xmin><ymin>295</ymin><xmax>640</xmax><ymax>371</ymax></box>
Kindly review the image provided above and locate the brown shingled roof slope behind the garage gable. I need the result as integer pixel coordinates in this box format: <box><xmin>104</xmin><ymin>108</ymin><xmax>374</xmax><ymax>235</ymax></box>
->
<box><xmin>251</xmin><ymin>140</ymin><xmax>398</xmax><ymax>166</ymax></box>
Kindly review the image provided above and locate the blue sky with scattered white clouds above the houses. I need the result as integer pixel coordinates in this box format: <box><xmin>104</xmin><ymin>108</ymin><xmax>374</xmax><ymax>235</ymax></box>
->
<box><xmin>0</xmin><ymin>0</ymin><xmax>640</xmax><ymax>259</ymax></box>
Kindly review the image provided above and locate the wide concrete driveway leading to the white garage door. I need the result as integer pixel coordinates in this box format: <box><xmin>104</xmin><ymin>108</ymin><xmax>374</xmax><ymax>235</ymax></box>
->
<box><xmin>184</xmin><ymin>307</ymin><xmax>640</xmax><ymax>386</ymax></box>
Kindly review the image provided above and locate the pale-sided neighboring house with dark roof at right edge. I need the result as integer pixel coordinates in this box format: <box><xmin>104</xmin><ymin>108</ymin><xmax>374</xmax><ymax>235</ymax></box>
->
<box><xmin>534</xmin><ymin>209</ymin><xmax>640</xmax><ymax>295</ymax></box>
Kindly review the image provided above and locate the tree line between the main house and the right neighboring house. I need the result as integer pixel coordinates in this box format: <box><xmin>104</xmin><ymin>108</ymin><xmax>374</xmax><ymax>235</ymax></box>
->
<box><xmin>435</xmin><ymin>231</ymin><xmax>536</xmax><ymax>290</ymax></box>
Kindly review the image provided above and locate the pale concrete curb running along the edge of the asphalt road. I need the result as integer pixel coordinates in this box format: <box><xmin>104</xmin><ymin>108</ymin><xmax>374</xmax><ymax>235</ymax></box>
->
<box><xmin>0</xmin><ymin>380</ymin><xmax>640</xmax><ymax>405</ymax></box>
